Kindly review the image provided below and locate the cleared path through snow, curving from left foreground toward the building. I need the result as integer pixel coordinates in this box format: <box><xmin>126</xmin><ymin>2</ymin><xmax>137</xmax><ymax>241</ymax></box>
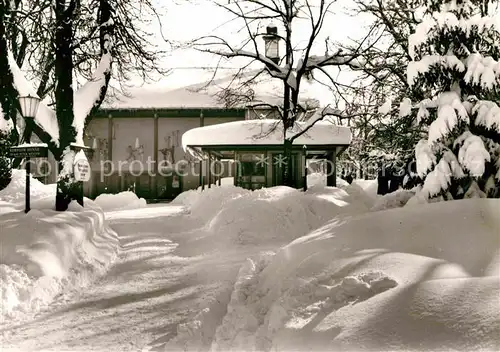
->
<box><xmin>0</xmin><ymin>205</ymin><xmax>241</xmax><ymax>351</ymax></box>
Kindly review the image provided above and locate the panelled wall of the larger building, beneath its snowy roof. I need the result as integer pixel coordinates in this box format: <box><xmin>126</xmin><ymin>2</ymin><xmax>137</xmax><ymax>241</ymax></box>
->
<box><xmin>81</xmin><ymin>116</ymin><xmax>242</xmax><ymax>198</ymax></box>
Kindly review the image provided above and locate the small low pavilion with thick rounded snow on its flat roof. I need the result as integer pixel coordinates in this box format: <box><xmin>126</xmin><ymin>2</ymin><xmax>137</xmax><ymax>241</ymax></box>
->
<box><xmin>182</xmin><ymin>119</ymin><xmax>352</xmax><ymax>189</ymax></box>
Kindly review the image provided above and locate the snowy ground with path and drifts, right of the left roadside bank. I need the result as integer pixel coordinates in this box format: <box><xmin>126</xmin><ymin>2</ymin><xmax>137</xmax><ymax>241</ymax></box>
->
<box><xmin>3</xmin><ymin>176</ymin><xmax>500</xmax><ymax>352</ymax></box>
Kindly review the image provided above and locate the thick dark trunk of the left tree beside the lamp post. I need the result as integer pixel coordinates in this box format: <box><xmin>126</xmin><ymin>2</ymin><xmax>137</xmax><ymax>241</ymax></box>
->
<box><xmin>55</xmin><ymin>0</ymin><xmax>78</xmax><ymax>211</ymax></box>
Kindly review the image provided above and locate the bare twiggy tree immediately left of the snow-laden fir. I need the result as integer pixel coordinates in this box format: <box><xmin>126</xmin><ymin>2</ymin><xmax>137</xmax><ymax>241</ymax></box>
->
<box><xmin>328</xmin><ymin>0</ymin><xmax>423</xmax><ymax>172</ymax></box>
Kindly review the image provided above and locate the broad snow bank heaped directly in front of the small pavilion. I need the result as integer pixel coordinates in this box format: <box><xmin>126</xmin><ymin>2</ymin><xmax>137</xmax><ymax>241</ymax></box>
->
<box><xmin>171</xmin><ymin>186</ymin><xmax>372</xmax><ymax>250</ymax></box>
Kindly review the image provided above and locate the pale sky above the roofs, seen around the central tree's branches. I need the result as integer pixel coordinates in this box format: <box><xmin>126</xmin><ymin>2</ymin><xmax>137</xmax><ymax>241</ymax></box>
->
<box><xmin>137</xmin><ymin>0</ymin><xmax>366</xmax><ymax>89</ymax></box>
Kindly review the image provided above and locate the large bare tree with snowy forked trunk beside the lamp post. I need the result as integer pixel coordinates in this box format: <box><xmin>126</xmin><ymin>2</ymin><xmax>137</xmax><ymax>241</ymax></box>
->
<box><xmin>0</xmin><ymin>0</ymin><xmax>170</xmax><ymax>210</ymax></box>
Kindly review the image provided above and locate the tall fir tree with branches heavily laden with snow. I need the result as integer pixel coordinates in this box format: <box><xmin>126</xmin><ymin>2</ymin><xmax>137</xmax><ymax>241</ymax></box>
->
<box><xmin>407</xmin><ymin>0</ymin><xmax>500</xmax><ymax>199</ymax></box>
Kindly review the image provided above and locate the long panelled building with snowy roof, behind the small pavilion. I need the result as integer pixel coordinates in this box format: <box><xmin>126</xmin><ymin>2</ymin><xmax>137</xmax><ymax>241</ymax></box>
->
<box><xmin>84</xmin><ymin>73</ymin><xmax>345</xmax><ymax>199</ymax></box>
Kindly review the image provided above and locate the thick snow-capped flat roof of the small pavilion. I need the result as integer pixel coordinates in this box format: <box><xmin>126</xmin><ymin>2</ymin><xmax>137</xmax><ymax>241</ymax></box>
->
<box><xmin>182</xmin><ymin>119</ymin><xmax>352</xmax><ymax>151</ymax></box>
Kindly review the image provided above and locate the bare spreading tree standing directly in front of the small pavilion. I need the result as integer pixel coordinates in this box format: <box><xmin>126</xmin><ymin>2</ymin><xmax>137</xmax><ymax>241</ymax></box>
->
<box><xmin>192</xmin><ymin>0</ymin><xmax>376</xmax><ymax>185</ymax></box>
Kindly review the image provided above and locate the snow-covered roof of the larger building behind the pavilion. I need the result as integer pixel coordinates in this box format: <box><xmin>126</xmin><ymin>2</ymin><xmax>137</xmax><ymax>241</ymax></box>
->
<box><xmin>101</xmin><ymin>70</ymin><xmax>332</xmax><ymax>109</ymax></box>
